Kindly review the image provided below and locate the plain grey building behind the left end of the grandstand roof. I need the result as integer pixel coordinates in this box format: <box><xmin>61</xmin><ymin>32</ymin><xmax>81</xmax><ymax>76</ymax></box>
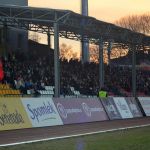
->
<box><xmin>0</xmin><ymin>0</ymin><xmax>28</xmax><ymax>51</ymax></box>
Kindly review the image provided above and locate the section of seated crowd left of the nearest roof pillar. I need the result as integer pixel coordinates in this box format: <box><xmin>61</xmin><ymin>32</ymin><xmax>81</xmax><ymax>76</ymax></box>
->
<box><xmin>3</xmin><ymin>52</ymin><xmax>54</xmax><ymax>94</ymax></box>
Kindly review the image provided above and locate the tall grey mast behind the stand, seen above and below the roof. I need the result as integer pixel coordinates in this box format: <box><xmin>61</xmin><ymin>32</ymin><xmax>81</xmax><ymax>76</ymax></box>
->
<box><xmin>81</xmin><ymin>0</ymin><xmax>89</xmax><ymax>63</ymax></box>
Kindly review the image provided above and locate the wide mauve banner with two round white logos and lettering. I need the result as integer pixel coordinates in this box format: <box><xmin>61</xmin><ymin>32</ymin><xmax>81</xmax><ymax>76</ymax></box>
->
<box><xmin>54</xmin><ymin>98</ymin><xmax>108</xmax><ymax>124</ymax></box>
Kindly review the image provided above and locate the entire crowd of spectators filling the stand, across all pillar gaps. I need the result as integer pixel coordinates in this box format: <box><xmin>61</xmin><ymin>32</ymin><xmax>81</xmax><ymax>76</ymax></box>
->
<box><xmin>3</xmin><ymin>48</ymin><xmax>150</xmax><ymax>96</ymax></box>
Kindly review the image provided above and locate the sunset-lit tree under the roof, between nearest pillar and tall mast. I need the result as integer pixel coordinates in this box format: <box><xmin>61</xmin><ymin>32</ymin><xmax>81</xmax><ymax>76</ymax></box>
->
<box><xmin>60</xmin><ymin>43</ymin><xmax>78</xmax><ymax>61</ymax></box>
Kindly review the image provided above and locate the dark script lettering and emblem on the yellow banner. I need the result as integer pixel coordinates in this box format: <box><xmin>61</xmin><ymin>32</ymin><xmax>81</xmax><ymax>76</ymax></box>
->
<box><xmin>0</xmin><ymin>104</ymin><xmax>24</xmax><ymax>126</ymax></box>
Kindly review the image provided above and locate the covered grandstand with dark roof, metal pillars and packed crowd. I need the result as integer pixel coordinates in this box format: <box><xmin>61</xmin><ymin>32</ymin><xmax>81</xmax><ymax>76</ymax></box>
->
<box><xmin>0</xmin><ymin>5</ymin><xmax>150</xmax><ymax>96</ymax></box>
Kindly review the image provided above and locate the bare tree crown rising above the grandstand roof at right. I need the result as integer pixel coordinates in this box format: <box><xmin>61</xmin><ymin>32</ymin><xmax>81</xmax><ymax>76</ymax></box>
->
<box><xmin>115</xmin><ymin>13</ymin><xmax>150</xmax><ymax>35</ymax></box>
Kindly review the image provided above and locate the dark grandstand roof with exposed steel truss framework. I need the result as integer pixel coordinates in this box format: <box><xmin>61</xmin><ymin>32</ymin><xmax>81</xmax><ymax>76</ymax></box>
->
<box><xmin>0</xmin><ymin>5</ymin><xmax>150</xmax><ymax>46</ymax></box>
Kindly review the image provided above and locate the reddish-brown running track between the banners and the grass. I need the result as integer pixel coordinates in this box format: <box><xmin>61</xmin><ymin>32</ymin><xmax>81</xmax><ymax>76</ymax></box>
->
<box><xmin>0</xmin><ymin>117</ymin><xmax>150</xmax><ymax>145</ymax></box>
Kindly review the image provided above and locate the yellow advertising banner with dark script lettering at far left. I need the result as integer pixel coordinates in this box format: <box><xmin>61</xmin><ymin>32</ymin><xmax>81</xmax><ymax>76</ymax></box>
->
<box><xmin>0</xmin><ymin>98</ymin><xmax>32</xmax><ymax>130</ymax></box>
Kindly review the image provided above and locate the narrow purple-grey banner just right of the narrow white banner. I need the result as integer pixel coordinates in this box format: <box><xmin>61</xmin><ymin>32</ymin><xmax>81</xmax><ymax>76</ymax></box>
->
<box><xmin>125</xmin><ymin>97</ymin><xmax>143</xmax><ymax>117</ymax></box>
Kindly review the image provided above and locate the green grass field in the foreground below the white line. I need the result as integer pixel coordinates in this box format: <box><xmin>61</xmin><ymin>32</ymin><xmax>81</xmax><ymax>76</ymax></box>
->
<box><xmin>0</xmin><ymin>127</ymin><xmax>150</xmax><ymax>150</ymax></box>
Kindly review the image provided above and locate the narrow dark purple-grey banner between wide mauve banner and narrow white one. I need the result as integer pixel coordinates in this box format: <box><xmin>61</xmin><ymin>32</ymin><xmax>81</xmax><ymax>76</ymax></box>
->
<box><xmin>101</xmin><ymin>97</ymin><xmax>122</xmax><ymax>120</ymax></box>
